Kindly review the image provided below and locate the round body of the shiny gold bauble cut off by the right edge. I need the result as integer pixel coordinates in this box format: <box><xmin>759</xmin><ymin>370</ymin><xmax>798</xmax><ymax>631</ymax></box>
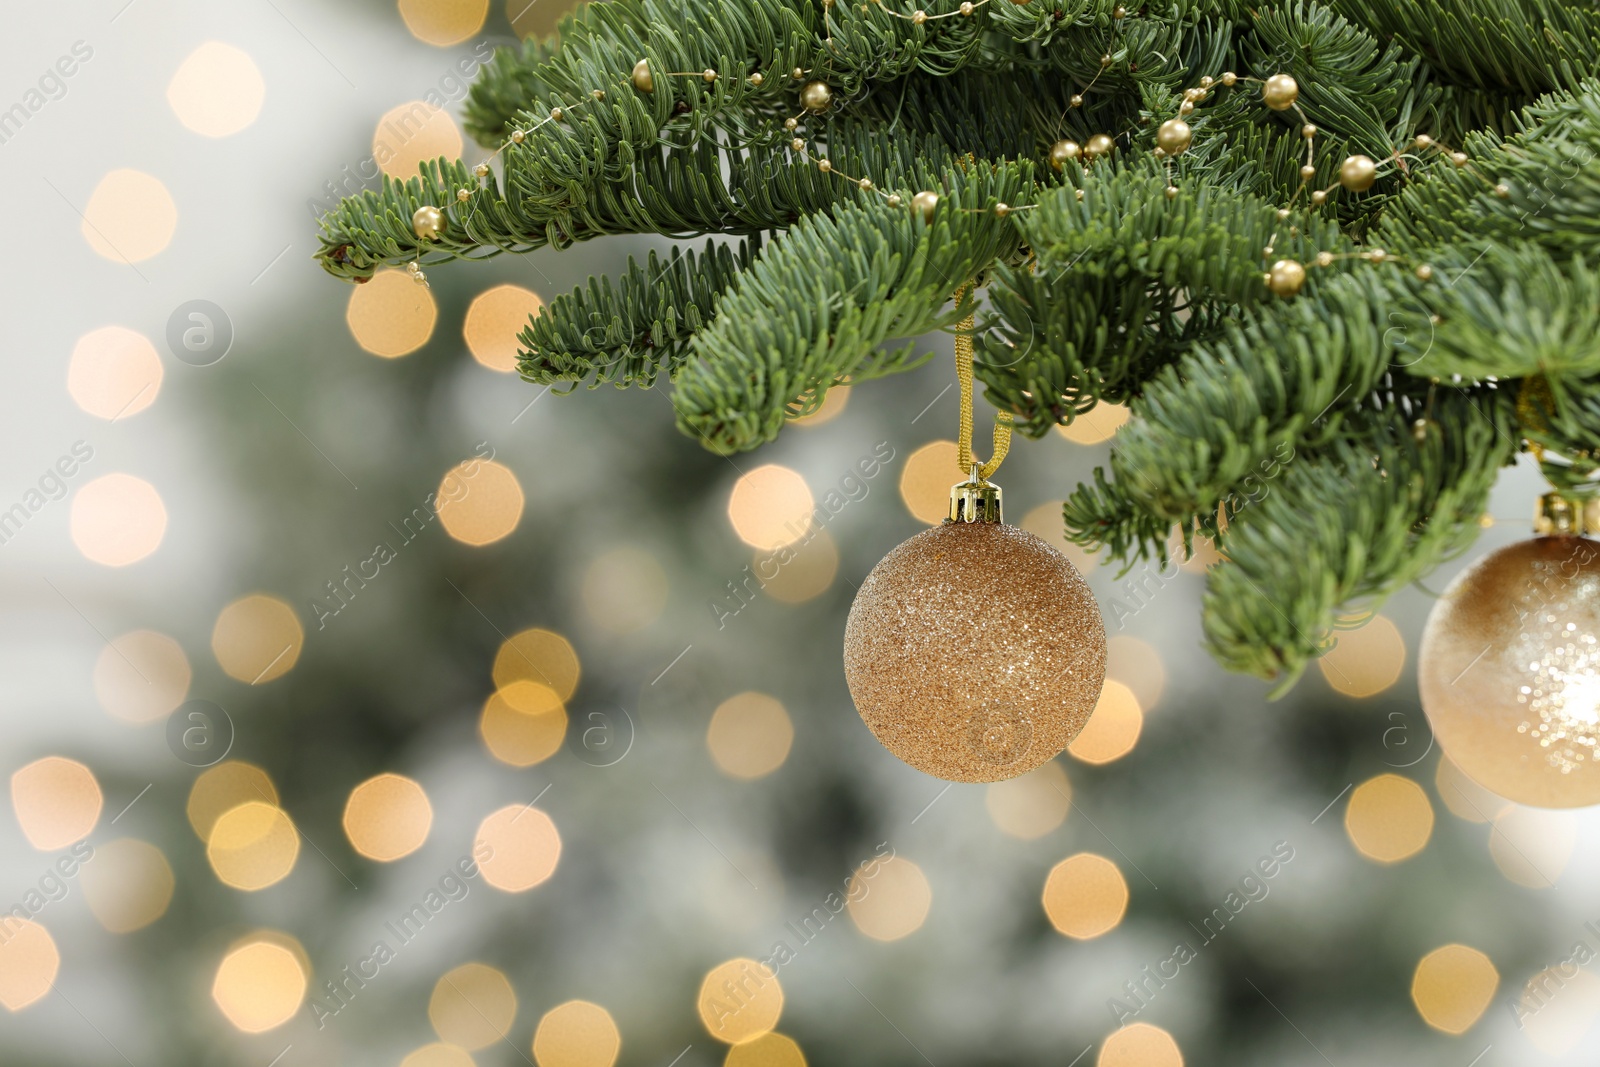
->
<box><xmin>1418</xmin><ymin>536</ymin><xmax>1600</xmax><ymax>808</ymax></box>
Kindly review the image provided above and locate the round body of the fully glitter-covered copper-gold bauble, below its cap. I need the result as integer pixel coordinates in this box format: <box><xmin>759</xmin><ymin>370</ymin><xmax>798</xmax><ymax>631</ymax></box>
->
<box><xmin>845</xmin><ymin>523</ymin><xmax>1106</xmax><ymax>782</ymax></box>
